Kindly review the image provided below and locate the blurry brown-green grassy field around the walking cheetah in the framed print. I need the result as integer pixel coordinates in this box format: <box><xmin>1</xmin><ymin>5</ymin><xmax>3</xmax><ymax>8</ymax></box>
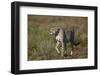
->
<box><xmin>28</xmin><ymin>15</ymin><xmax>88</xmax><ymax>61</ymax></box>
